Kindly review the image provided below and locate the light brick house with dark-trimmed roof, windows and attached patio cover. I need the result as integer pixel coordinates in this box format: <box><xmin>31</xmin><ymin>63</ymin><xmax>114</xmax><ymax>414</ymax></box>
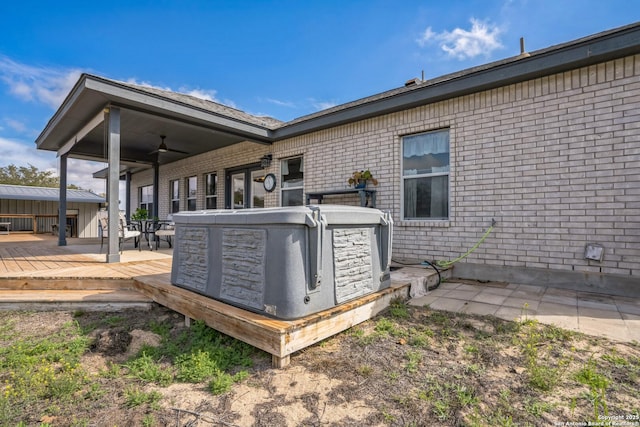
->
<box><xmin>37</xmin><ymin>23</ymin><xmax>640</xmax><ymax>296</ymax></box>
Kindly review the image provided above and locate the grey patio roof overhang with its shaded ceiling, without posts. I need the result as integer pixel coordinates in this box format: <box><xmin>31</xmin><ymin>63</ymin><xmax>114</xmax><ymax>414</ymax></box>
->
<box><xmin>36</xmin><ymin>74</ymin><xmax>271</xmax><ymax>172</ymax></box>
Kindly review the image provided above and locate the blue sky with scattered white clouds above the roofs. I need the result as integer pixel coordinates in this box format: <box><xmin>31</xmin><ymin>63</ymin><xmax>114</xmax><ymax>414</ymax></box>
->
<box><xmin>0</xmin><ymin>0</ymin><xmax>640</xmax><ymax>192</ymax></box>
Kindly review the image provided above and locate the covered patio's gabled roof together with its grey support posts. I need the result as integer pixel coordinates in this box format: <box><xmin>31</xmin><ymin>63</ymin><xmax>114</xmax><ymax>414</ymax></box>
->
<box><xmin>36</xmin><ymin>74</ymin><xmax>280</xmax><ymax>263</ymax></box>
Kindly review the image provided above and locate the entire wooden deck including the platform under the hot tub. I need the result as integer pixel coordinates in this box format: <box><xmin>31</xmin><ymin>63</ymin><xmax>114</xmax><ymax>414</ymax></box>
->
<box><xmin>0</xmin><ymin>234</ymin><xmax>430</xmax><ymax>367</ymax></box>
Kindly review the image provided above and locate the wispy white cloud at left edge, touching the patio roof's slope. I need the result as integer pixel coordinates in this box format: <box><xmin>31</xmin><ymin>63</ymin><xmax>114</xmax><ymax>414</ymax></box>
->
<box><xmin>0</xmin><ymin>56</ymin><xmax>82</xmax><ymax>108</ymax></box>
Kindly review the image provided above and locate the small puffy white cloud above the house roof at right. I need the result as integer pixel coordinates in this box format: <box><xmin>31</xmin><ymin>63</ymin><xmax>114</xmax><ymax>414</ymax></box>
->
<box><xmin>417</xmin><ymin>18</ymin><xmax>502</xmax><ymax>60</ymax></box>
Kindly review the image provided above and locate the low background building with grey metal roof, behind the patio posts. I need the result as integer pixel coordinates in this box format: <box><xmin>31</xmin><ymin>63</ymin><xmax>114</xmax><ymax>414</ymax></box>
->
<box><xmin>0</xmin><ymin>184</ymin><xmax>105</xmax><ymax>238</ymax></box>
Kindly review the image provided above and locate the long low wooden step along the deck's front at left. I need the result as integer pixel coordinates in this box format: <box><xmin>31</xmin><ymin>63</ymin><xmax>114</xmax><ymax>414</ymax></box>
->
<box><xmin>0</xmin><ymin>289</ymin><xmax>153</xmax><ymax>311</ymax></box>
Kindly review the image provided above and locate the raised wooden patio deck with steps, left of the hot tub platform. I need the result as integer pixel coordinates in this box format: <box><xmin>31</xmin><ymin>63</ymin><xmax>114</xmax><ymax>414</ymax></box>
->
<box><xmin>0</xmin><ymin>234</ymin><xmax>172</xmax><ymax>310</ymax></box>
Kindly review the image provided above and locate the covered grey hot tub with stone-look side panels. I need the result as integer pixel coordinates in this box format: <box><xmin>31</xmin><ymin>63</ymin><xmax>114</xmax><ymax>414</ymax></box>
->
<box><xmin>171</xmin><ymin>205</ymin><xmax>393</xmax><ymax>319</ymax></box>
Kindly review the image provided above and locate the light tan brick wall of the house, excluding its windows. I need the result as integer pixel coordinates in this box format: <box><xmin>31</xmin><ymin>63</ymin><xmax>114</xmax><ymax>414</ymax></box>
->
<box><xmin>132</xmin><ymin>56</ymin><xmax>640</xmax><ymax>277</ymax></box>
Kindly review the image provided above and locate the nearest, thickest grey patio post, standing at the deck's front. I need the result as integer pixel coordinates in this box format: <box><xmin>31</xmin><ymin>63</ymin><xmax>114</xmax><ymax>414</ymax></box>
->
<box><xmin>105</xmin><ymin>105</ymin><xmax>120</xmax><ymax>263</ymax></box>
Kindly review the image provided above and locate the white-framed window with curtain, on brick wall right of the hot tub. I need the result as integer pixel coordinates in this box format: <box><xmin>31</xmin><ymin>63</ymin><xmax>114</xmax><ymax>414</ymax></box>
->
<box><xmin>402</xmin><ymin>129</ymin><xmax>449</xmax><ymax>220</ymax></box>
